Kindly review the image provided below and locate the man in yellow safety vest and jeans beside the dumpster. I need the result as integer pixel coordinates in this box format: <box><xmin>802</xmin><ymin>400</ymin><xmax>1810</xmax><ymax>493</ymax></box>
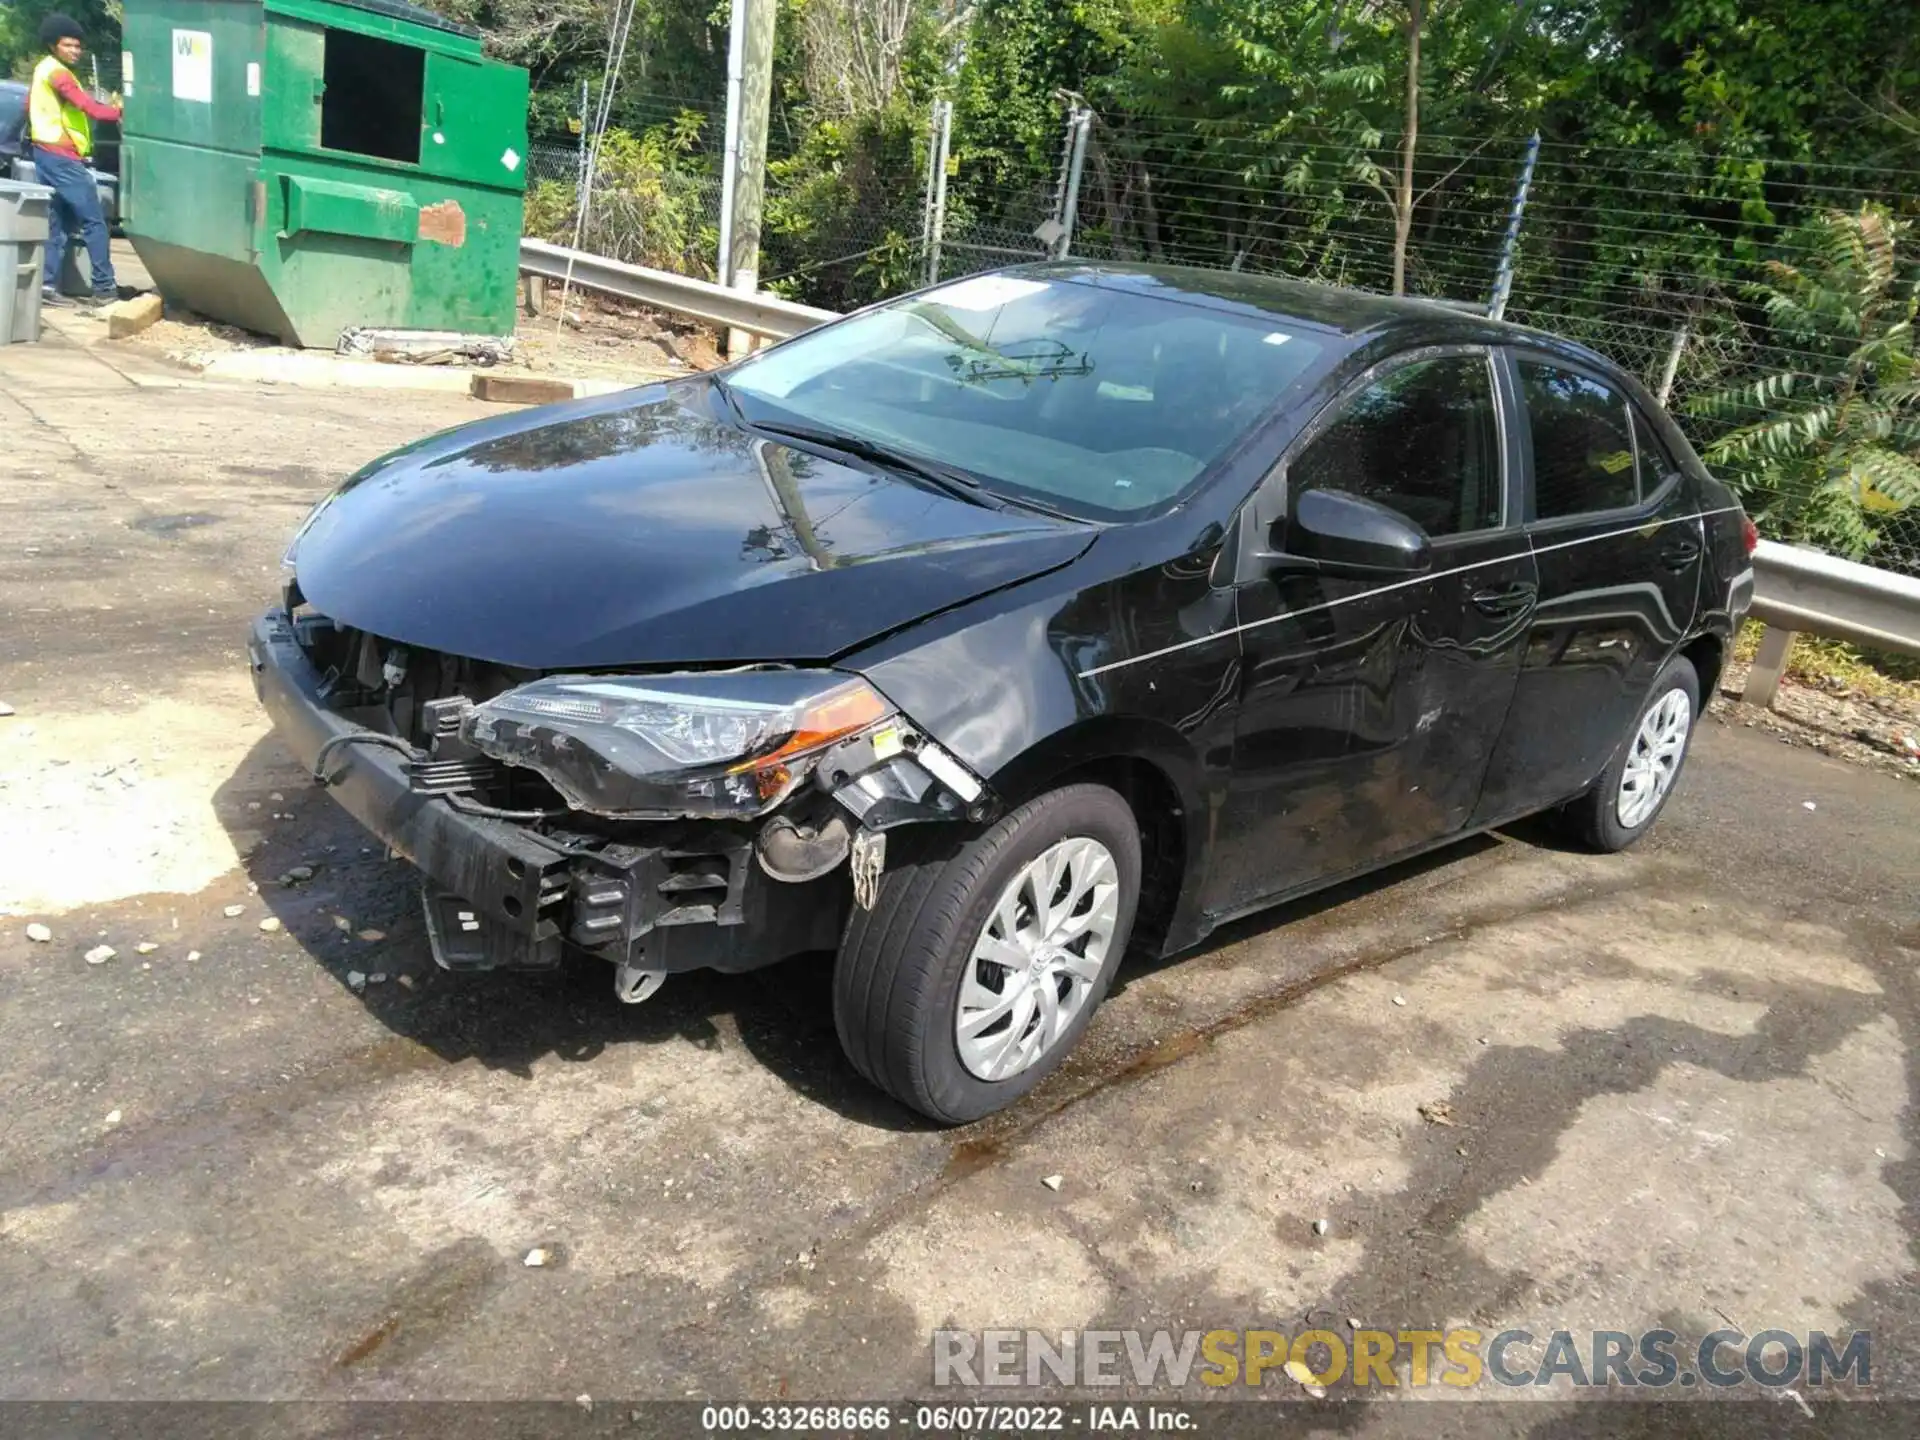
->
<box><xmin>27</xmin><ymin>13</ymin><xmax>119</xmax><ymax>305</ymax></box>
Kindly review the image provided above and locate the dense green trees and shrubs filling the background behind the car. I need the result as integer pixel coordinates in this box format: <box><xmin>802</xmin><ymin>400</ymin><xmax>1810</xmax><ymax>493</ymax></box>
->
<box><xmin>30</xmin><ymin>0</ymin><xmax>1920</xmax><ymax>566</ymax></box>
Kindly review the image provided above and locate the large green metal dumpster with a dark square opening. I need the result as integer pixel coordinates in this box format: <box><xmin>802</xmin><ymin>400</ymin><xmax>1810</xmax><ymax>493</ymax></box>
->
<box><xmin>121</xmin><ymin>0</ymin><xmax>526</xmax><ymax>348</ymax></box>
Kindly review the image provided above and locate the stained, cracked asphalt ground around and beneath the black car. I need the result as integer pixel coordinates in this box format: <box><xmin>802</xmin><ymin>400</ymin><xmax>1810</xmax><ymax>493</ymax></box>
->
<box><xmin>0</xmin><ymin>314</ymin><xmax>1920</xmax><ymax>1434</ymax></box>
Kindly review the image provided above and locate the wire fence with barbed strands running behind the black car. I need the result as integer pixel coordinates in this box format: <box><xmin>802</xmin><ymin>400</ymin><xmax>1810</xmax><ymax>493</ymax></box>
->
<box><xmin>545</xmin><ymin>100</ymin><xmax>1920</xmax><ymax>572</ymax></box>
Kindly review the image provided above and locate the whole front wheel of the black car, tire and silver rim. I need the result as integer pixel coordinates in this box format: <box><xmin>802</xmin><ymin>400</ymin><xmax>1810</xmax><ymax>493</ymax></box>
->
<box><xmin>833</xmin><ymin>785</ymin><xmax>1140</xmax><ymax>1125</ymax></box>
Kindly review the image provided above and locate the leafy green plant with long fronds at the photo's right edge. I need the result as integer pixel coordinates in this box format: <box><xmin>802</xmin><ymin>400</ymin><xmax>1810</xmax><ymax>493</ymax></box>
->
<box><xmin>1695</xmin><ymin>205</ymin><xmax>1920</xmax><ymax>559</ymax></box>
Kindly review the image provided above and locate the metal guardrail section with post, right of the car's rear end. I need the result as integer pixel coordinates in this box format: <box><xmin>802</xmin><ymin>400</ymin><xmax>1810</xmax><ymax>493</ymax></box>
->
<box><xmin>1745</xmin><ymin>540</ymin><xmax>1920</xmax><ymax>705</ymax></box>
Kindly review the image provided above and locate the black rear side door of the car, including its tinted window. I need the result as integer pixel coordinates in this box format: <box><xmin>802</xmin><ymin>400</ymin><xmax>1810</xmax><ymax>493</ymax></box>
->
<box><xmin>1475</xmin><ymin>349</ymin><xmax>1705</xmax><ymax>824</ymax></box>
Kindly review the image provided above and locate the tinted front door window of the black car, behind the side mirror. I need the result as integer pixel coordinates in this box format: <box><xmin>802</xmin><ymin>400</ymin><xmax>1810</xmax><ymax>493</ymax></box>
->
<box><xmin>1288</xmin><ymin>355</ymin><xmax>1500</xmax><ymax>536</ymax></box>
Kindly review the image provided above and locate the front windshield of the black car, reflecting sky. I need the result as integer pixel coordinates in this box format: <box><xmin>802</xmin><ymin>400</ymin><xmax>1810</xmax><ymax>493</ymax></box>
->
<box><xmin>728</xmin><ymin>275</ymin><xmax>1321</xmax><ymax>518</ymax></box>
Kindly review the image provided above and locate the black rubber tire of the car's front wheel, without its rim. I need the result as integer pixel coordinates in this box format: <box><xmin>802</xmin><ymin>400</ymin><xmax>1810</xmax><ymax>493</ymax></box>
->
<box><xmin>833</xmin><ymin>785</ymin><xmax>1140</xmax><ymax>1125</ymax></box>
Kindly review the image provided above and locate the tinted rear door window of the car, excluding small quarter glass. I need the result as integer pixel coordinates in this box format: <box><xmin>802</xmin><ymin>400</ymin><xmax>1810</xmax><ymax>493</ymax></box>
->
<box><xmin>1521</xmin><ymin>361</ymin><xmax>1640</xmax><ymax>520</ymax></box>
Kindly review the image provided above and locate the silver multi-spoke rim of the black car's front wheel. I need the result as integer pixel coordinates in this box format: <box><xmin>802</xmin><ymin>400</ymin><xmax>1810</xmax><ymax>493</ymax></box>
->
<box><xmin>954</xmin><ymin>835</ymin><xmax>1119</xmax><ymax>1081</ymax></box>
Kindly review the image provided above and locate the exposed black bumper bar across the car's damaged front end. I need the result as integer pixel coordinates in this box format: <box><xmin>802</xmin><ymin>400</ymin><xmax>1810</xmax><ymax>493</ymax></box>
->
<box><xmin>248</xmin><ymin>611</ymin><xmax>849</xmax><ymax>972</ymax></box>
